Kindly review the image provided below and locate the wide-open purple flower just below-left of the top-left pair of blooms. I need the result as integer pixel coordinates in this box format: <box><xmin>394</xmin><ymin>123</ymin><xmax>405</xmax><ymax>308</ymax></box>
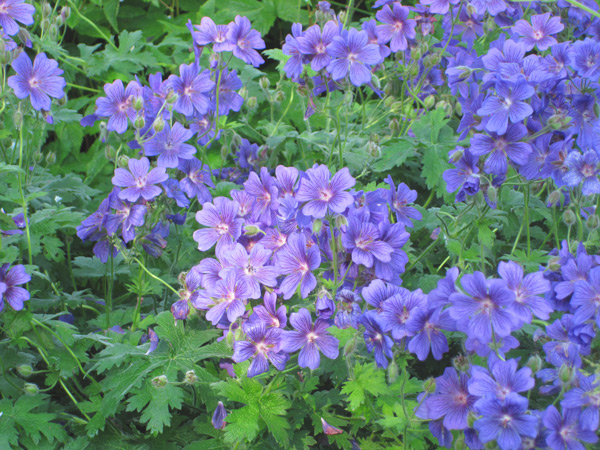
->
<box><xmin>168</xmin><ymin>63</ymin><xmax>215</xmax><ymax>116</ymax></box>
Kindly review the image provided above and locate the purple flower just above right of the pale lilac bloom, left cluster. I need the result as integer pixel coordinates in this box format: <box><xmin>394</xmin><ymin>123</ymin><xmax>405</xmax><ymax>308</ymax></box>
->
<box><xmin>144</xmin><ymin>122</ymin><xmax>196</xmax><ymax>168</ymax></box>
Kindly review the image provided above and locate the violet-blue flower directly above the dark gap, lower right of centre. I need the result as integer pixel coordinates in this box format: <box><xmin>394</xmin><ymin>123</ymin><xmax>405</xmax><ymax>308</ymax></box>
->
<box><xmin>406</xmin><ymin>307</ymin><xmax>455</xmax><ymax>361</ymax></box>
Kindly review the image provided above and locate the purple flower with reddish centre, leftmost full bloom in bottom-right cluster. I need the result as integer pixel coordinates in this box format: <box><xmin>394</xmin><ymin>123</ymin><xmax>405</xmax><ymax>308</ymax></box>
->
<box><xmin>416</xmin><ymin>367</ymin><xmax>477</xmax><ymax>430</ymax></box>
